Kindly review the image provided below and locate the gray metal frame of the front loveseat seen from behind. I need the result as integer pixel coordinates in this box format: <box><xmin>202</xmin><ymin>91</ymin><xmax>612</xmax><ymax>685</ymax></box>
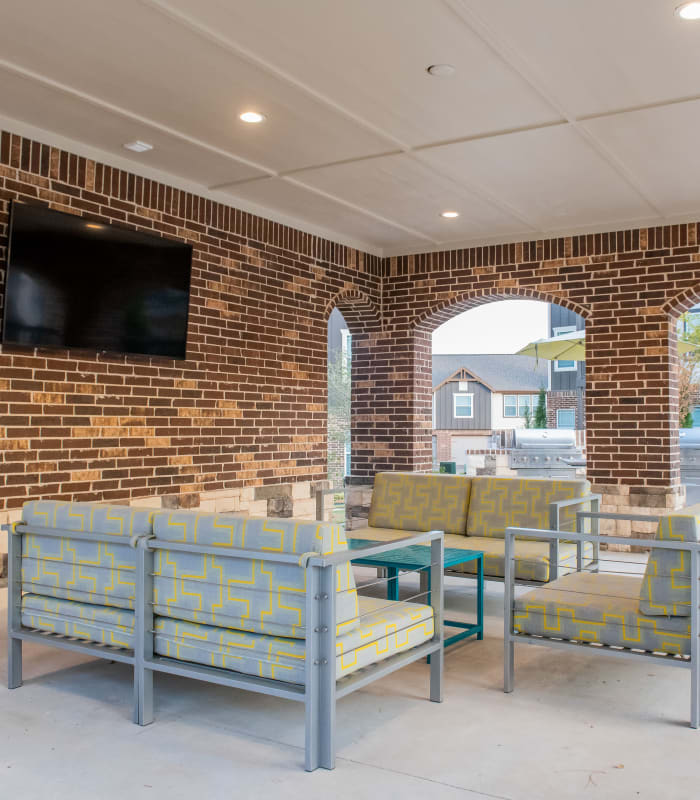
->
<box><xmin>8</xmin><ymin>525</ymin><xmax>444</xmax><ymax>771</ymax></box>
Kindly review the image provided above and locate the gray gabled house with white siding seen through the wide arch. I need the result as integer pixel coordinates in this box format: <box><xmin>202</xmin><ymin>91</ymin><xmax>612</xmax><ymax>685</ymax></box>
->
<box><xmin>433</xmin><ymin>354</ymin><xmax>549</xmax><ymax>463</ymax></box>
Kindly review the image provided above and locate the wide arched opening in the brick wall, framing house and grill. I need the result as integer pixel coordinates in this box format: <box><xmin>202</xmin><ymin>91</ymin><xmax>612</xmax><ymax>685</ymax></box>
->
<box><xmin>415</xmin><ymin>289</ymin><xmax>588</xmax><ymax>477</ymax></box>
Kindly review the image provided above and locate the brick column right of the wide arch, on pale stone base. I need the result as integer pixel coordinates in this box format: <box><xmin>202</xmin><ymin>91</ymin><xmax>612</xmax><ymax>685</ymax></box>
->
<box><xmin>586</xmin><ymin>310</ymin><xmax>683</xmax><ymax>535</ymax></box>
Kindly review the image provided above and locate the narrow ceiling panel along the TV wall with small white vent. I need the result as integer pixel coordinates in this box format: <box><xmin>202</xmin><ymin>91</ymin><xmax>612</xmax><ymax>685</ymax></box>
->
<box><xmin>0</xmin><ymin>67</ymin><xmax>265</xmax><ymax>187</ymax></box>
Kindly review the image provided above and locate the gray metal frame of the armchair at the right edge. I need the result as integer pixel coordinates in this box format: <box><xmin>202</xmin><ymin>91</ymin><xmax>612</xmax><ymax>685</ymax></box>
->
<box><xmin>503</xmin><ymin>528</ymin><xmax>700</xmax><ymax>728</ymax></box>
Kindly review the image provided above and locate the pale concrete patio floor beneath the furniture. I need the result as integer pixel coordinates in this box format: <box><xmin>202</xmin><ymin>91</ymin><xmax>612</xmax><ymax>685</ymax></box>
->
<box><xmin>0</xmin><ymin>579</ymin><xmax>700</xmax><ymax>800</ymax></box>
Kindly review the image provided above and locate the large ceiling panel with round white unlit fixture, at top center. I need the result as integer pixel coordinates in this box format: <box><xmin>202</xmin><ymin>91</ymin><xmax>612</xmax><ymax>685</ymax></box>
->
<box><xmin>158</xmin><ymin>0</ymin><xmax>558</xmax><ymax>146</ymax></box>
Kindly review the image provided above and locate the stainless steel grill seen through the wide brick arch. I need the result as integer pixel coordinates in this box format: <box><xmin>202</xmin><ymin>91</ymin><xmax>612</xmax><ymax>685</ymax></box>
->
<box><xmin>508</xmin><ymin>428</ymin><xmax>586</xmax><ymax>478</ymax></box>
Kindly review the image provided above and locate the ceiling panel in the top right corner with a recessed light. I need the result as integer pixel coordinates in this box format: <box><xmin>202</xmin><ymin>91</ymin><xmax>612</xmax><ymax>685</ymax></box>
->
<box><xmin>460</xmin><ymin>0</ymin><xmax>700</xmax><ymax>116</ymax></box>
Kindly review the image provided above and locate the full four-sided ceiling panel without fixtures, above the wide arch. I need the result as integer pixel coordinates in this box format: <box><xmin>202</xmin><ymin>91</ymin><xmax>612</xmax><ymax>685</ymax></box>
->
<box><xmin>422</xmin><ymin>125</ymin><xmax>653</xmax><ymax>231</ymax></box>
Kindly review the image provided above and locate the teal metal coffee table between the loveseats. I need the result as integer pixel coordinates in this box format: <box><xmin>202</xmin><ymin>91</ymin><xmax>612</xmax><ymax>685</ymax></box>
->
<box><xmin>348</xmin><ymin>539</ymin><xmax>484</xmax><ymax>647</ymax></box>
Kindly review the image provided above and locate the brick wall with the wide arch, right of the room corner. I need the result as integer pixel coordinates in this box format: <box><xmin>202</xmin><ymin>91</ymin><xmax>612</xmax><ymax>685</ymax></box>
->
<box><xmin>377</xmin><ymin>233</ymin><xmax>700</xmax><ymax>507</ymax></box>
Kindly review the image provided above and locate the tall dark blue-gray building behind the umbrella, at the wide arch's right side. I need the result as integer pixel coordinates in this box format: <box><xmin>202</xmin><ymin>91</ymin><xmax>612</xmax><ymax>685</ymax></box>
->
<box><xmin>547</xmin><ymin>304</ymin><xmax>586</xmax><ymax>430</ymax></box>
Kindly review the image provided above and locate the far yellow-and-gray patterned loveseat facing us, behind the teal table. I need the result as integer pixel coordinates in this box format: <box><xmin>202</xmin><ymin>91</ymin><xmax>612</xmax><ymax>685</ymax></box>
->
<box><xmin>352</xmin><ymin>472</ymin><xmax>600</xmax><ymax>583</ymax></box>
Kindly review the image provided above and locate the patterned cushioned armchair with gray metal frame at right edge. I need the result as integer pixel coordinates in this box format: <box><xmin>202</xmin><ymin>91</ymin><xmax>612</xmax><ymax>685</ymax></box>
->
<box><xmin>504</xmin><ymin>505</ymin><xmax>700</xmax><ymax>728</ymax></box>
